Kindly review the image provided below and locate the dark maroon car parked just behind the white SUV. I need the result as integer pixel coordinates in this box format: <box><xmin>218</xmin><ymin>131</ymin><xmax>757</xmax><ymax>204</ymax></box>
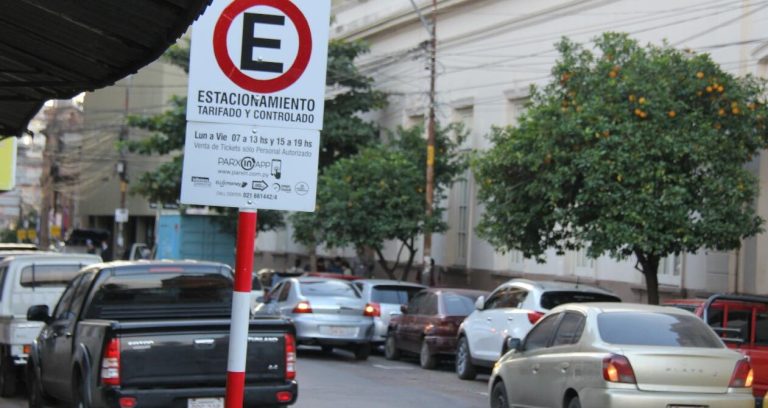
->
<box><xmin>384</xmin><ymin>288</ymin><xmax>488</xmax><ymax>369</ymax></box>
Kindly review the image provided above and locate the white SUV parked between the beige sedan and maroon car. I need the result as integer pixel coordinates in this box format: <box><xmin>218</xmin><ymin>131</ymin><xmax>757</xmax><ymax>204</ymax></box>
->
<box><xmin>456</xmin><ymin>279</ymin><xmax>621</xmax><ymax>380</ymax></box>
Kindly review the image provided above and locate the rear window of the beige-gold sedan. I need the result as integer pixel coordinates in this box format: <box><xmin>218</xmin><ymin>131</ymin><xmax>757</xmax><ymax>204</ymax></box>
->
<box><xmin>597</xmin><ymin>312</ymin><xmax>724</xmax><ymax>348</ymax></box>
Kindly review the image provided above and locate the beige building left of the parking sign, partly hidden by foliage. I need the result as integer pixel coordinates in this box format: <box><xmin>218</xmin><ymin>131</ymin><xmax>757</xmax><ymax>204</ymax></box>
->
<box><xmin>77</xmin><ymin>61</ymin><xmax>187</xmax><ymax>257</ymax></box>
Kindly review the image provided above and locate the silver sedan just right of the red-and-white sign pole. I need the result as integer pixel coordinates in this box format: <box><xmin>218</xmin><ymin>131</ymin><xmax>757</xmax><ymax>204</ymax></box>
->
<box><xmin>259</xmin><ymin>277</ymin><xmax>373</xmax><ymax>360</ymax></box>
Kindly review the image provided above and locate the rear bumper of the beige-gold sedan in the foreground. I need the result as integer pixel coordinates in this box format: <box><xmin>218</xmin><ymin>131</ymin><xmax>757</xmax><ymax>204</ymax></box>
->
<box><xmin>579</xmin><ymin>389</ymin><xmax>755</xmax><ymax>408</ymax></box>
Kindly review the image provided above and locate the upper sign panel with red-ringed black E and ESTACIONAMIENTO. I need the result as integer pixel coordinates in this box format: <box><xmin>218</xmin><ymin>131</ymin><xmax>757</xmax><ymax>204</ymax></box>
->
<box><xmin>187</xmin><ymin>0</ymin><xmax>331</xmax><ymax>130</ymax></box>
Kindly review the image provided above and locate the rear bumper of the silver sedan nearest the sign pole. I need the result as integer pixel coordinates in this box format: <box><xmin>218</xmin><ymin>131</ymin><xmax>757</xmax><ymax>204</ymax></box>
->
<box><xmin>294</xmin><ymin>316</ymin><xmax>373</xmax><ymax>346</ymax></box>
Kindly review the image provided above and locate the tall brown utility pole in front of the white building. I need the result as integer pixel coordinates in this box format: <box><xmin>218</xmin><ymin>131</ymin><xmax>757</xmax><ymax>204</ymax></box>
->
<box><xmin>423</xmin><ymin>0</ymin><xmax>437</xmax><ymax>285</ymax></box>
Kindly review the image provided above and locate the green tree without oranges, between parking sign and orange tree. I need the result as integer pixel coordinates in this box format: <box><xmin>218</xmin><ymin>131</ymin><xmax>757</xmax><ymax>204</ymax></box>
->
<box><xmin>314</xmin><ymin>125</ymin><xmax>467</xmax><ymax>280</ymax></box>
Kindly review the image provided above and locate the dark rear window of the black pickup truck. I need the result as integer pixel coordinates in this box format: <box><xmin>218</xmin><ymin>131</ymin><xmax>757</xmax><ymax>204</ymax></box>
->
<box><xmin>86</xmin><ymin>272</ymin><xmax>232</xmax><ymax>320</ymax></box>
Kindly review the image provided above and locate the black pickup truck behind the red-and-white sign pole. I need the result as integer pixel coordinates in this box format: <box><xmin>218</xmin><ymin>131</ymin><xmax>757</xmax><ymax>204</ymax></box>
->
<box><xmin>27</xmin><ymin>261</ymin><xmax>298</xmax><ymax>408</ymax></box>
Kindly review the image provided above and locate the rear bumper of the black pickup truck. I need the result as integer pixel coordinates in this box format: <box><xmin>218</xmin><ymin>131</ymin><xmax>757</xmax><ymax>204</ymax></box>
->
<box><xmin>99</xmin><ymin>381</ymin><xmax>299</xmax><ymax>408</ymax></box>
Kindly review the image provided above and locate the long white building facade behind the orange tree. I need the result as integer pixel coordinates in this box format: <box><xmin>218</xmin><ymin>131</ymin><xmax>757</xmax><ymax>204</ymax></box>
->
<box><xmin>331</xmin><ymin>0</ymin><xmax>768</xmax><ymax>301</ymax></box>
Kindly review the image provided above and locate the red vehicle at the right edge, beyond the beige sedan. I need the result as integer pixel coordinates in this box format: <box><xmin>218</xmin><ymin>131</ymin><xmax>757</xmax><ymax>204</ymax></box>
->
<box><xmin>664</xmin><ymin>295</ymin><xmax>768</xmax><ymax>406</ymax></box>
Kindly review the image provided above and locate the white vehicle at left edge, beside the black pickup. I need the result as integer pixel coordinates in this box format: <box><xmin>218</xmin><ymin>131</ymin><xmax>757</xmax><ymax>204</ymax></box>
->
<box><xmin>0</xmin><ymin>251</ymin><xmax>101</xmax><ymax>397</ymax></box>
